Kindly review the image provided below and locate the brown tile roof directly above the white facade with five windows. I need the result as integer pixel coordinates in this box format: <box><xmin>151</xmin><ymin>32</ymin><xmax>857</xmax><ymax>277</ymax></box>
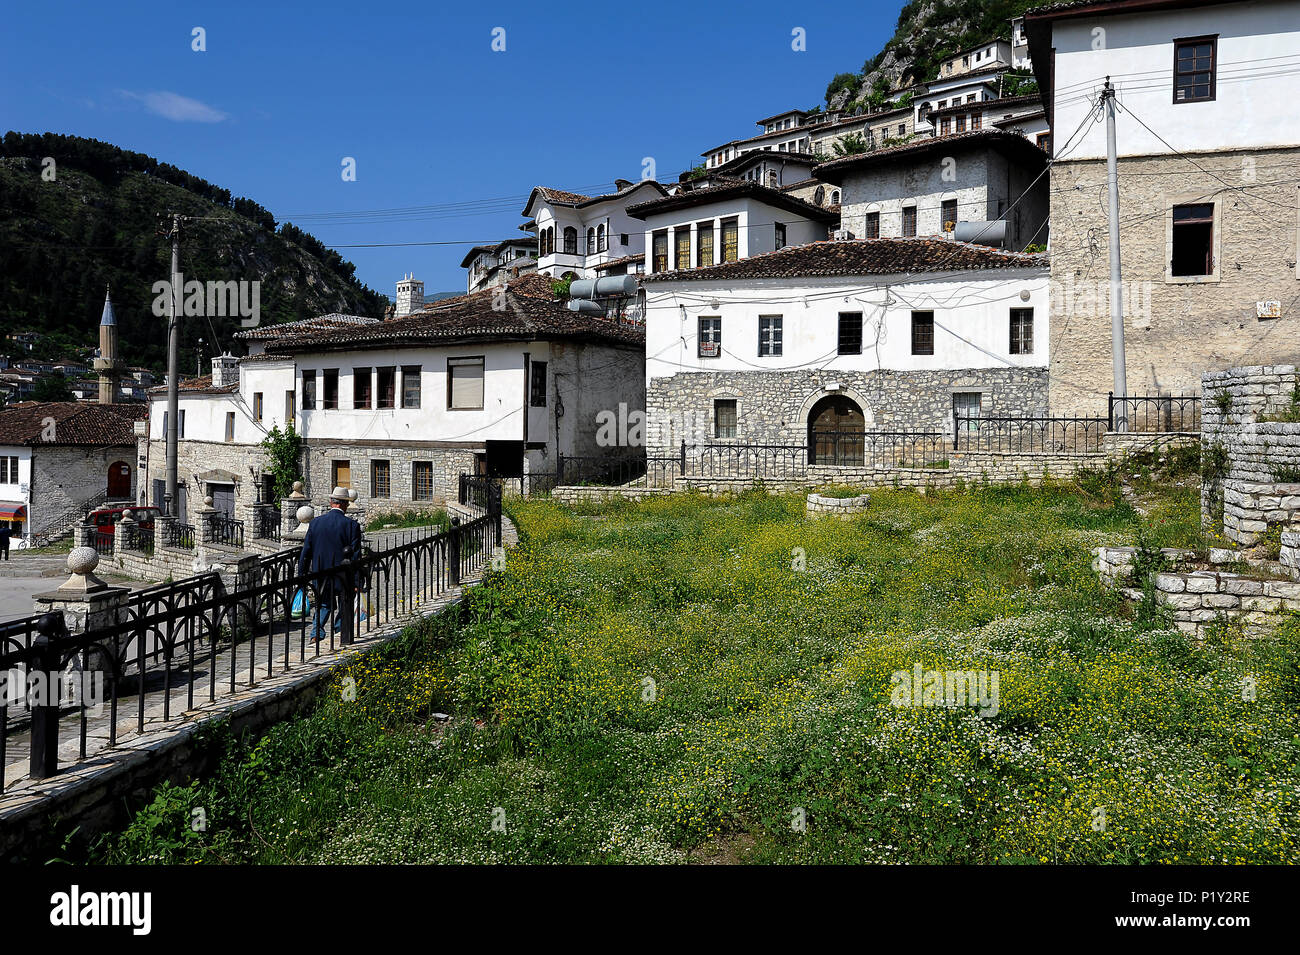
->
<box><xmin>641</xmin><ymin>238</ymin><xmax>1049</xmax><ymax>282</ymax></box>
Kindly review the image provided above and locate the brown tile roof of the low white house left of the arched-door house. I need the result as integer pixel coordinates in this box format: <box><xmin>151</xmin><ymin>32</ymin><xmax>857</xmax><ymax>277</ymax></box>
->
<box><xmin>267</xmin><ymin>273</ymin><xmax>645</xmax><ymax>352</ymax></box>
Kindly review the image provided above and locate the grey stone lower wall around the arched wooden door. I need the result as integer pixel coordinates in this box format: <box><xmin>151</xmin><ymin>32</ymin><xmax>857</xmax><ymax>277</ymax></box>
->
<box><xmin>646</xmin><ymin>368</ymin><xmax>1048</xmax><ymax>455</ymax></box>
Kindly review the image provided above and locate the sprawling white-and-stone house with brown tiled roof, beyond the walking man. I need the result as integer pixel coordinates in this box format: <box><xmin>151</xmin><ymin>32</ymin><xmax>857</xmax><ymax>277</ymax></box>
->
<box><xmin>147</xmin><ymin>273</ymin><xmax>644</xmax><ymax>527</ymax></box>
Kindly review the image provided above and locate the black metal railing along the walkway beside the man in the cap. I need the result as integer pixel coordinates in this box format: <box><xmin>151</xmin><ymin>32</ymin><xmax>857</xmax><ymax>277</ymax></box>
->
<box><xmin>0</xmin><ymin>476</ymin><xmax>502</xmax><ymax>793</ymax></box>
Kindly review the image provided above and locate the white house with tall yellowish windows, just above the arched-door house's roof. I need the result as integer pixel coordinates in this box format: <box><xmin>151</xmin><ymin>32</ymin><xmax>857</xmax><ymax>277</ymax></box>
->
<box><xmin>628</xmin><ymin>179</ymin><xmax>839</xmax><ymax>274</ymax></box>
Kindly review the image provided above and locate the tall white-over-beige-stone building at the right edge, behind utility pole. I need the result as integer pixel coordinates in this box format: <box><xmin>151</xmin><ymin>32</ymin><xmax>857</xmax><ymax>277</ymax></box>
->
<box><xmin>1024</xmin><ymin>0</ymin><xmax>1300</xmax><ymax>413</ymax></box>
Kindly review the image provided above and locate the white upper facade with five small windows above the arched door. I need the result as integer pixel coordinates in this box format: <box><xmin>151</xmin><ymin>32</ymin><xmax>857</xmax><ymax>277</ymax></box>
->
<box><xmin>646</xmin><ymin>266</ymin><xmax>1050</xmax><ymax>383</ymax></box>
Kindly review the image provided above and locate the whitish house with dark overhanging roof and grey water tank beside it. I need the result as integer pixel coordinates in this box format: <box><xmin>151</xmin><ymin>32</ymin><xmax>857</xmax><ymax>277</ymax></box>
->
<box><xmin>814</xmin><ymin>130</ymin><xmax>1048</xmax><ymax>251</ymax></box>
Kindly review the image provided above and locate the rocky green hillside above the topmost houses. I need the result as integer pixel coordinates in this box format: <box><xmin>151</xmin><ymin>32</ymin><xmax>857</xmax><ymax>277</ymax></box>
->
<box><xmin>826</xmin><ymin>0</ymin><xmax>1044</xmax><ymax>109</ymax></box>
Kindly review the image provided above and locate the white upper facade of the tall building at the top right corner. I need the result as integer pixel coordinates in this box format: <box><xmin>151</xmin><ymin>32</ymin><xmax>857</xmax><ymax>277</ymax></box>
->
<box><xmin>1039</xmin><ymin>0</ymin><xmax>1300</xmax><ymax>160</ymax></box>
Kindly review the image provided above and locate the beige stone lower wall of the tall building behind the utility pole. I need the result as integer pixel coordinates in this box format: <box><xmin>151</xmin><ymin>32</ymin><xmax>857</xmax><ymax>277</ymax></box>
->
<box><xmin>1049</xmin><ymin>148</ymin><xmax>1300</xmax><ymax>414</ymax></box>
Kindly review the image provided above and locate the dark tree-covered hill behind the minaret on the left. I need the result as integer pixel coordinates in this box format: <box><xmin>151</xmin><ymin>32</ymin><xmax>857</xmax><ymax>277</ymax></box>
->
<box><xmin>0</xmin><ymin>133</ymin><xmax>386</xmax><ymax>369</ymax></box>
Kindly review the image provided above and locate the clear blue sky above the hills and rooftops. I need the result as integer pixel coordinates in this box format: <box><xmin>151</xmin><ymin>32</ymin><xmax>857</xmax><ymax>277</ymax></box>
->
<box><xmin>0</xmin><ymin>0</ymin><xmax>901</xmax><ymax>296</ymax></box>
